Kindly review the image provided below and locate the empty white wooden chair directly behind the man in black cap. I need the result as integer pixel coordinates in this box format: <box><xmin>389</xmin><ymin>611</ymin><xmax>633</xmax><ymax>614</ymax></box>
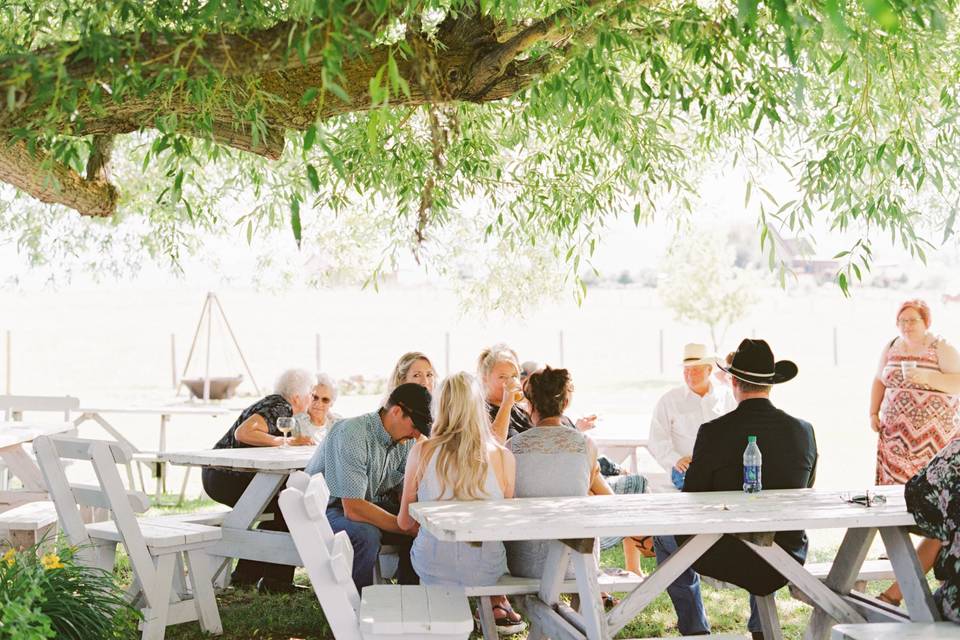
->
<box><xmin>280</xmin><ymin>471</ymin><xmax>473</xmax><ymax>640</ymax></box>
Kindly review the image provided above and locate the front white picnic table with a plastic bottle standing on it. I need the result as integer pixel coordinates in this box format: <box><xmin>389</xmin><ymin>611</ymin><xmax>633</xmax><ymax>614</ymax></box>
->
<box><xmin>410</xmin><ymin>486</ymin><xmax>939</xmax><ymax>640</ymax></box>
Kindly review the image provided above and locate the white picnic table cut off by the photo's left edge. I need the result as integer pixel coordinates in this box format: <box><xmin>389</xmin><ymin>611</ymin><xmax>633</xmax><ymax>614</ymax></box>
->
<box><xmin>0</xmin><ymin>421</ymin><xmax>75</xmax><ymax>509</ymax></box>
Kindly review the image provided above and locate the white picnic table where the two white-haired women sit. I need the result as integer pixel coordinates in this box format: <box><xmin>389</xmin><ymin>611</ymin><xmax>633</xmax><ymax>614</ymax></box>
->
<box><xmin>160</xmin><ymin>446</ymin><xmax>316</xmax><ymax>575</ymax></box>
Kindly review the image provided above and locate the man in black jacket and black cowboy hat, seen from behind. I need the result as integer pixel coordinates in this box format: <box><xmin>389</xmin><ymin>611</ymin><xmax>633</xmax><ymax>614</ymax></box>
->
<box><xmin>657</xmin><ymin>339</ymin><xmax>817</xmax><ymax>639</ymax></box>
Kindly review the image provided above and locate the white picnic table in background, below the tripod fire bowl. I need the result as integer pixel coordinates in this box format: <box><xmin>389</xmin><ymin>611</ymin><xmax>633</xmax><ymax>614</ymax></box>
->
<box><xmin>73</xmin><ymin>404</ymin><xmax>237</xmax><ymax>500</ymax></box>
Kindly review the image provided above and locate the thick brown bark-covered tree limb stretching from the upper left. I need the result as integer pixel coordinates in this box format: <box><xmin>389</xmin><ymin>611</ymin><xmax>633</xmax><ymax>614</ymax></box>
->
<box><xmin>0</xmin><ymin>9</ymin><xmax>569</xmax><ymax>216</ymax></box>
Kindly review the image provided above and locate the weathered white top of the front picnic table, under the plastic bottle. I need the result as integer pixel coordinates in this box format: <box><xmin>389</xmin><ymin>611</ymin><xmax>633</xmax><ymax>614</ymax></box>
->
<box><xmin>410</xmin><ymin>486</ymin><xmax>914</xmax><ymax>542</ymax></box>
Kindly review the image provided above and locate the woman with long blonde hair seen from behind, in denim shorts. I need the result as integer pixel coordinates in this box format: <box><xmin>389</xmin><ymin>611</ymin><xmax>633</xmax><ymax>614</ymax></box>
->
<box><xmin>397</xmin><ymin>372</ymin><xmax>525</xmax><ymax>633</ymax></box>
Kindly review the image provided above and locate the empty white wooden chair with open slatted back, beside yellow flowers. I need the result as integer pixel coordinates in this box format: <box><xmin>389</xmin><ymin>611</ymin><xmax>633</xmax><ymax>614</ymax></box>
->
<box><xmin>33</xmin><ymin>436</ymin><xmax>223</xmax><ymax>640</ymax></box>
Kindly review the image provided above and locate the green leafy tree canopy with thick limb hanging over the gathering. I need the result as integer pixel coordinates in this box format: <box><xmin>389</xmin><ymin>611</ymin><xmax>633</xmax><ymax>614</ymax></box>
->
<box><xmin>0</xmin><ymin>0</ymin><xmax>960</xmax><ymax>288</ymax></box>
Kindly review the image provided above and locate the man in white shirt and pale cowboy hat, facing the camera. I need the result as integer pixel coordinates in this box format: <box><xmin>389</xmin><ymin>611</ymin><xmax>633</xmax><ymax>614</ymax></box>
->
<box><xmin>647</xmin><ymin>343</ymin><xmax>737</xmax><ymax>489</ymax></box>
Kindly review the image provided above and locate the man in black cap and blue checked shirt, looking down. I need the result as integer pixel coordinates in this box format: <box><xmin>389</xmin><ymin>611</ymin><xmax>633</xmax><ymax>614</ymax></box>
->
<box><xmin>306</xmin><ymin>383</ymin><xmax>433</xmax><ymax>589</ymax></box>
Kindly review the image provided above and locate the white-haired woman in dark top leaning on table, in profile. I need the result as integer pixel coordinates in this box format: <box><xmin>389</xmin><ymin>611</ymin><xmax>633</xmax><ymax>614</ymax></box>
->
<box><xmin>202</xmin><ymin>369</ymin><xmax>332</xmax><ymax>592</ymax></box>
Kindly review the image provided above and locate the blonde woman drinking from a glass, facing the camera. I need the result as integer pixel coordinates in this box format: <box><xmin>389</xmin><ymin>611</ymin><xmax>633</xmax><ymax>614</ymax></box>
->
<box><xmin>477</xmin><ymin>343</ymin><xmax>533</xmax><ymax>443</ymax></box>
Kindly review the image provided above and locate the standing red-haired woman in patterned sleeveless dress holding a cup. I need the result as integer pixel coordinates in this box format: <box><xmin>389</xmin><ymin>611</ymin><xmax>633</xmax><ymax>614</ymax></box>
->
<box><xmin>870</xmin><ymin>300</ymin><xmax>960</xmax><ymax>604</ymax></box>
